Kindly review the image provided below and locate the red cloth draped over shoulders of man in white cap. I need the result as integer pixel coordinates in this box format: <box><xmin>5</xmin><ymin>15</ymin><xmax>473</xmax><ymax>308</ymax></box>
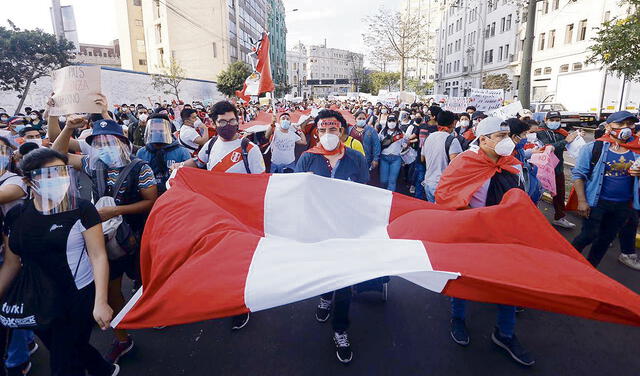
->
<box><xmin>436</xmin><ymin>149</ymin><xmax>521</xmax><ymax>209</ymax></box>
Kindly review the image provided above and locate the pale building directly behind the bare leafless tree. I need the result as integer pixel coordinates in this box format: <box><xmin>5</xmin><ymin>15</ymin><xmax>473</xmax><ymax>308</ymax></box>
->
<box><xmin>400</xmin><ymin>0</ymin><xmax>445</xmax><ymax>82</ymax></box>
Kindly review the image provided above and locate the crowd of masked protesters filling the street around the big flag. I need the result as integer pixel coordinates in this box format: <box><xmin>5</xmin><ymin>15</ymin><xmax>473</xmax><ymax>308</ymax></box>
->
<box><xmin>0</xmin><ymin>91</ymin><xmax>640</xmax><ymax>376</ymax></box>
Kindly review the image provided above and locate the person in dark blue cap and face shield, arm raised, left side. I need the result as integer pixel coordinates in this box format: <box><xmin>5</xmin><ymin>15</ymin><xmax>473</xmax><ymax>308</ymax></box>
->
<box><xmin>52</xmin><ymin>113</ymin><xmax>158</xmax><ymax>363</ymax></box>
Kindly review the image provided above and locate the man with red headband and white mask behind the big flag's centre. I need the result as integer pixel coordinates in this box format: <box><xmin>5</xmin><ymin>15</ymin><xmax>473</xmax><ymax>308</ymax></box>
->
<box><xmin>296</xmin><ymin>110</ymin><xmax>369</xmax><ymax>363</ymax></box>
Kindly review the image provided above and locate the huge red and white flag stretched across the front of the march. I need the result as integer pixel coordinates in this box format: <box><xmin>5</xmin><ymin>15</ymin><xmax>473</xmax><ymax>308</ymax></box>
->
<box><xmin>112</xmin><ymin>168</ymin><xmax>640</xmax><ymax>328</ymax></box>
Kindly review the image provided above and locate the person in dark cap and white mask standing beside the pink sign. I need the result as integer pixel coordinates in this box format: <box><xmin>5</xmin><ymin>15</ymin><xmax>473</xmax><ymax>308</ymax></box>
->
<box><xmin>536</xmin><ymin>111</ymin><xmax>579</xmax><ymax>229</ymax></box>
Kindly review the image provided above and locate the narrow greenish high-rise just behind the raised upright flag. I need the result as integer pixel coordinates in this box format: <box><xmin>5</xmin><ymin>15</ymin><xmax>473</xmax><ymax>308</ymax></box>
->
<box><xmin>267</xmin><ymin>0</ymin><xmax>288</xmax><ymax>87</ymax></box>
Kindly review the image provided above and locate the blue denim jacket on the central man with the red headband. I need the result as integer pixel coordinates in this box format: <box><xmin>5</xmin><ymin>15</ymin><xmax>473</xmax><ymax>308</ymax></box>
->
<box><xmin>296</xmin><ymin>148</ymin><xmax>369</xmax><ymax>184</ymax></box>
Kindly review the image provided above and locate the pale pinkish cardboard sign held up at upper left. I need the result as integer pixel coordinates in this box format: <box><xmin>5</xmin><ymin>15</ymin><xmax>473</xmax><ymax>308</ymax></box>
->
<box><xmin>49</xmin><ymin>65</ymin><xmax>102</xmax><ymax>116</ymax></box>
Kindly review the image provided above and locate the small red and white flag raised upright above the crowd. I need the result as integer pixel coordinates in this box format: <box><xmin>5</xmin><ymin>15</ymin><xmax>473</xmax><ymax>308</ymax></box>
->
<box><xmin>236</xmin><ymin>33</ymin><xmax>275</xmax><ymax>102</ymax></box>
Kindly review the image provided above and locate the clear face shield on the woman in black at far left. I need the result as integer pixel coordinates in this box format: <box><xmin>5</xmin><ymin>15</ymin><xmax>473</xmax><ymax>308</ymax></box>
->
<box><xmin>28</xmin><ymin>166</ymin><xmax>80</xmax><ymax>215</ymax></box>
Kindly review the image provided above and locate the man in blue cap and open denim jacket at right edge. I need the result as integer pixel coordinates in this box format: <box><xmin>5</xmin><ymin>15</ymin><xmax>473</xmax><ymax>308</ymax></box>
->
<box><xmin>570</xmin><ymin>111</ymin><xmax>640</xmax><ymax>270</ymax></box>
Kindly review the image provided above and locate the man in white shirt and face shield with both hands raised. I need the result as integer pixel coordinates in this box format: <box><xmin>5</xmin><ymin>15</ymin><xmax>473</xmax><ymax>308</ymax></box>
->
<box><xmin>265</xmin><ymin>112</ymin><xmax>307</xmax><ymax>173</ymax></box>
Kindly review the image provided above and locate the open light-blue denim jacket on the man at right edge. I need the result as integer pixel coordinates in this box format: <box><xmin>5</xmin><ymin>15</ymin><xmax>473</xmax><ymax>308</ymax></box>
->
<box><xmin>571</xmin><ymin>142</ymin><xmax>640</xmax><ymax>210</ymax></box>
